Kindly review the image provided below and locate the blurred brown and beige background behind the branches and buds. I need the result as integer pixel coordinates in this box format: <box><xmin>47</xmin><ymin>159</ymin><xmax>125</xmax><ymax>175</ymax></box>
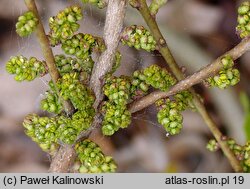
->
<box><xmin>0</xmin><ymin>0</ymin><xmax>250</xmax><ymax>172</ymax></box>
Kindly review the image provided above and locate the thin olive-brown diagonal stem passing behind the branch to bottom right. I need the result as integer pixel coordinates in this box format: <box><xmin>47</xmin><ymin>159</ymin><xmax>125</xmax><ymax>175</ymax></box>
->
<box><xmin>136</xmin><ymin>0</ymin><xmax>242</xmax><ymax>172</ymax></box>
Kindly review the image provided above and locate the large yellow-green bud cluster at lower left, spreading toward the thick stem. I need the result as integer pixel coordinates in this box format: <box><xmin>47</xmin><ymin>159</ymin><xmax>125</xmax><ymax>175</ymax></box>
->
<box><xmin>23</xmin><ymin>105</ymin><xmax>94</xmax><ymax>147</ymax></box>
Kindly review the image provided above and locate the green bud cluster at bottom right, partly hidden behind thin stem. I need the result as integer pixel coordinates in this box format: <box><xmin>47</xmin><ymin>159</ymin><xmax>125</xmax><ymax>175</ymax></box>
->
<box><xmin>207</xmin><ymin>138</ymin><xmax>250</xmax><ymax>173</ymax></box>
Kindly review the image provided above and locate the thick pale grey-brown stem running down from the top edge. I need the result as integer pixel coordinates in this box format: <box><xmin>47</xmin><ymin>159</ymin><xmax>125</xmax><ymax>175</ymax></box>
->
<box><xmin>90</xmin><ymin>0</ymin><xmax>126</xmax><ymax>108</ymax></box>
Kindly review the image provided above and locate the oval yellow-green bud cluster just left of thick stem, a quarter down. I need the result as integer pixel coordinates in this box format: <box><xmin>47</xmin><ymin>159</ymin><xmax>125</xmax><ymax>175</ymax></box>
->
<box><xmin>62</xmin><ymin>33</ymin><xmax>97</xmax><ymax>60</ymax></box>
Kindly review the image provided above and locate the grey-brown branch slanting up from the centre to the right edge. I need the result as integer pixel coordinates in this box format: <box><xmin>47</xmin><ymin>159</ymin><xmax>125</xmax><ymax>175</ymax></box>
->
<box><xmin>129</xmin><ymin>38</ymin><xmax>250</xmax><ymax>113</ymax></box>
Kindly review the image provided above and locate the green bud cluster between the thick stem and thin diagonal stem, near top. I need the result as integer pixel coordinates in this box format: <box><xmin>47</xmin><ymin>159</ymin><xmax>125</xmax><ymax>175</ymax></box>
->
<box><xmin>121</xmin><ymin>25</ymin><xmax>156</xmax><ymax>52</ymax></box>
